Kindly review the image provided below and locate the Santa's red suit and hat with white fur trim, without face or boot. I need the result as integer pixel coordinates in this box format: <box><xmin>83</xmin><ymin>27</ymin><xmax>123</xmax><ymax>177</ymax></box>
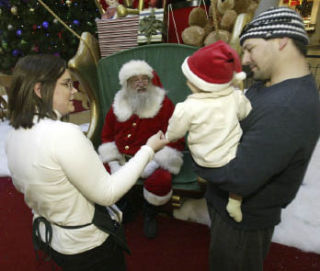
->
<box><xmin>98</xmin><ymin>60</ymin><xmax>184</xmax><ymax>206</ymax></box>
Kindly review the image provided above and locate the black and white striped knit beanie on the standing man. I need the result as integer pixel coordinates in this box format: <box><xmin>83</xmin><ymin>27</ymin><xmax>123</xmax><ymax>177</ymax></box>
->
<box><xmin>240</xmin><ymin>7</ymin><xmax>309</xmax><ymax>45</ymax></box>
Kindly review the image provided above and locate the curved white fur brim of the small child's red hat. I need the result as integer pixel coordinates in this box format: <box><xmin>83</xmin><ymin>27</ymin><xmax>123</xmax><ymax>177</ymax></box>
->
<box><xmin>181</xmin><ymin>57</ymin><xmax>232</xmax><ymax>92</ymax></box>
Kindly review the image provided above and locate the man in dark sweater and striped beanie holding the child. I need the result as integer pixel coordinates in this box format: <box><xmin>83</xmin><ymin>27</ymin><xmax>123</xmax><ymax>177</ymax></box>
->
<box><xmin>196</xmin><ymin>8</ymin><xmax>320</xmax><ymax>271</ymax></box>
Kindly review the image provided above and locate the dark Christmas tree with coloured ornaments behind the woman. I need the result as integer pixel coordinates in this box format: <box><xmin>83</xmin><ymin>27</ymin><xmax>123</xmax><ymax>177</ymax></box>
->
<box><xmin>0</xmin><ymin>0</ymin><xmax>100</xmax><ymax>74</ymax></box>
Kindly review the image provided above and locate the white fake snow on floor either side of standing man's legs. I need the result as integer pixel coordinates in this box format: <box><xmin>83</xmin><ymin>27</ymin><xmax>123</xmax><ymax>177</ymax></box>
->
<box><xmin>173</xmin><ymin>140</ymin><xmax>320</xmax><ymax>254</ymax></box>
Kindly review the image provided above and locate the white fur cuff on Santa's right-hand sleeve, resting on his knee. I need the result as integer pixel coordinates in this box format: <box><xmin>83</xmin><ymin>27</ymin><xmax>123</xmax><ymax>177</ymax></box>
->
<box><xmin>154</xmin><ymin>146</ymin><xmax>183</xmax><ymax>174</ymax></box>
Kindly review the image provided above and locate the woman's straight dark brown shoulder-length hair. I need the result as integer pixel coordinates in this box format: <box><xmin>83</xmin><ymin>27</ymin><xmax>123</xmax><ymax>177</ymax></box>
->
<box><xmin>8</xmin><ymin>55</ymin><xmax>67</xmax><ymax>129</ymax></box>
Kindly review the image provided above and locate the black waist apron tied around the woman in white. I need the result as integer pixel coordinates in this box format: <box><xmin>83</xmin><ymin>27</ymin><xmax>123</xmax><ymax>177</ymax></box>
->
<box><xmin>32</xmin><ymin>204</ymin><xmax>131</xmax><ymax>257</ymax></box>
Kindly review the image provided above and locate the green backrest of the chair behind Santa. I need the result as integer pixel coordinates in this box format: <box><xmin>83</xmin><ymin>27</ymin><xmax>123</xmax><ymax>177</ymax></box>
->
<box><xmin>94</xmin><ymin>43</ymin><xmax>198</xmax><ymax>149</ymax></box>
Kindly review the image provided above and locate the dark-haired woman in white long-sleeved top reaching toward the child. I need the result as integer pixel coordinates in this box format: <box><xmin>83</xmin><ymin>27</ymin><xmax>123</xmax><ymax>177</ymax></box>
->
<box><xmin>6</xmin><ymin>55</ymin><xmax>167</xmax><ymax>271</ymax></box>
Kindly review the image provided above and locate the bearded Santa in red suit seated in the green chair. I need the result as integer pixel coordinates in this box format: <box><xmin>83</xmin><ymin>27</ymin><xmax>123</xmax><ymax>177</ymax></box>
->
<box><xmin>98</xmin><ymin>60</ymin><xmax>184</xmax><ymax>238</ymax></box>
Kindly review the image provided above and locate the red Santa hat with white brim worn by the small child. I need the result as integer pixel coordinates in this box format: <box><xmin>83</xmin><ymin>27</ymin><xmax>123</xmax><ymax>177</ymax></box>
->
<box><xmin>181</xmin><ymin>40</ymin><xmax>246</xmax><ymax>92</ymax></box>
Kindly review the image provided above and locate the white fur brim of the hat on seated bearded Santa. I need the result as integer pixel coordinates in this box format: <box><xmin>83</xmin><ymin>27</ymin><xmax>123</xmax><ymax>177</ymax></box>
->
<box><xmin>119</xmin><ymin>60</ymin><xmax>153</xmax><ymax>87</ymax></box>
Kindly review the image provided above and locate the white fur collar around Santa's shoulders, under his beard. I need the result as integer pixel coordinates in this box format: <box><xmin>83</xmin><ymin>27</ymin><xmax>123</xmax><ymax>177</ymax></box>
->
<box><xmin>112</xmin><ymin>87</ymin><xmax>166</xmax><ymax>122</ymax></box>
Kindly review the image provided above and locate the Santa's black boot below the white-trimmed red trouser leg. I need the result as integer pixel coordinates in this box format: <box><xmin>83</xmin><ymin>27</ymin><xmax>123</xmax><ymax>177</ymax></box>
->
<box><xmin>143</xmin><ymin>201</ymin><xmax>158</xmax><ymax>239</ymax></box>
